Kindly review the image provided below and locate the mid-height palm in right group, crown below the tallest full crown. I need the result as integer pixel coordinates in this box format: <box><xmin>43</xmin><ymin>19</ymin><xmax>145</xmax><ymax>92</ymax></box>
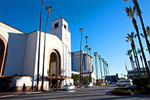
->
<box><xmin>126</xmin><ymin>32</ymin><xmax>142</xmax><ymax>78</ymax></box>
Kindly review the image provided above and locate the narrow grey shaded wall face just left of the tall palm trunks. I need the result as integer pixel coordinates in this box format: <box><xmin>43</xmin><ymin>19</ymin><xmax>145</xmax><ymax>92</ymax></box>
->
<box><xmin>23</xmin><ymin>32</ymin><xmax>38</xmax><ymax>76</ymax></box>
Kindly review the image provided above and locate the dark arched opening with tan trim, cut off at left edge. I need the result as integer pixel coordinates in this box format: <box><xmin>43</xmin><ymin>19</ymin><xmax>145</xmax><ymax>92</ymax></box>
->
<box><xmin>0</xmin><ymin>35</ymin><xmax>7</xmax><ymax>76</ymax></box>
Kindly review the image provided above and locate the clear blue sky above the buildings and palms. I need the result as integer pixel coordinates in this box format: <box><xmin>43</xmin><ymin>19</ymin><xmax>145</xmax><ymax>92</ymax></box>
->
<box><xmin>0</xmin><ymin>0</ymin><xmax>150</xmax><ymax>77</ymax></box>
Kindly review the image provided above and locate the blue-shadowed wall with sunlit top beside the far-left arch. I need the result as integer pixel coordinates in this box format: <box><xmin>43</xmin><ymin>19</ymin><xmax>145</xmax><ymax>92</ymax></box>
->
<box><xmin>0</xmin><ymin>22</ymin><xmax>26</xmax><ymax>76</ymax></box>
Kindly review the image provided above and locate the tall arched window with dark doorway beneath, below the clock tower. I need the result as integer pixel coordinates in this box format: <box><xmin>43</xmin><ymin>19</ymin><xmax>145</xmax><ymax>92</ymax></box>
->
<box><xmin>47</xmin><ymin>50</ymin><xmax>61</xmax><ymax>88</ymax></box>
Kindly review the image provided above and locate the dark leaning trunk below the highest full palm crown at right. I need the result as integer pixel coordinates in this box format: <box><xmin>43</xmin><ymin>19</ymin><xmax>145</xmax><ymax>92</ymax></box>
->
<box><xmin>132</xmin><ymin>18</ymin><xmax>150</xmax><ymax>84</ymax></box>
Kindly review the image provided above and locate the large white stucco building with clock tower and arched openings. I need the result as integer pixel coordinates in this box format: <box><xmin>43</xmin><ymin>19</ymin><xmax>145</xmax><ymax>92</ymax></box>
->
<box><xmin>0</xmin><ymin>18</ymin><xmax>73</xmax><ymax>90</ymax></box>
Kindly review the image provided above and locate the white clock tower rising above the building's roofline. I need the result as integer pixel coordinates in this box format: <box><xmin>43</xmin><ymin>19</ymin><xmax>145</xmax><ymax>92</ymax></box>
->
<box><xmin>49</xmin><ymin>18</ymin><xmax>71</xmax><ymax>51</ymax></box>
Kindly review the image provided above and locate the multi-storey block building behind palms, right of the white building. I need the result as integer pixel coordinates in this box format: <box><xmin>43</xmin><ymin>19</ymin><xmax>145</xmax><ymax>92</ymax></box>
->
<box><xmin>71</xmin><ymin>51</ymin><xmax>93</xmax><ymax>73</ymax></box>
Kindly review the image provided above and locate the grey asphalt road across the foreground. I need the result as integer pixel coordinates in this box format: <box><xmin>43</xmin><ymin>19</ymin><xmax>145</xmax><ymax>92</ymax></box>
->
<box><xmin>0</xmin><ymin>85</ymin><xmax>150</xmax><ymax>100</ymax></box>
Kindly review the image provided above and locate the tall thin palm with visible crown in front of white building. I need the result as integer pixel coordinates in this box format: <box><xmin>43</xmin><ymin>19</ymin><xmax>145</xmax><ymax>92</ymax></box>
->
<box><xmin>41</xmin><ymin>5</ymin><xmax>53</xmax><ymax>90</ymax></box>
